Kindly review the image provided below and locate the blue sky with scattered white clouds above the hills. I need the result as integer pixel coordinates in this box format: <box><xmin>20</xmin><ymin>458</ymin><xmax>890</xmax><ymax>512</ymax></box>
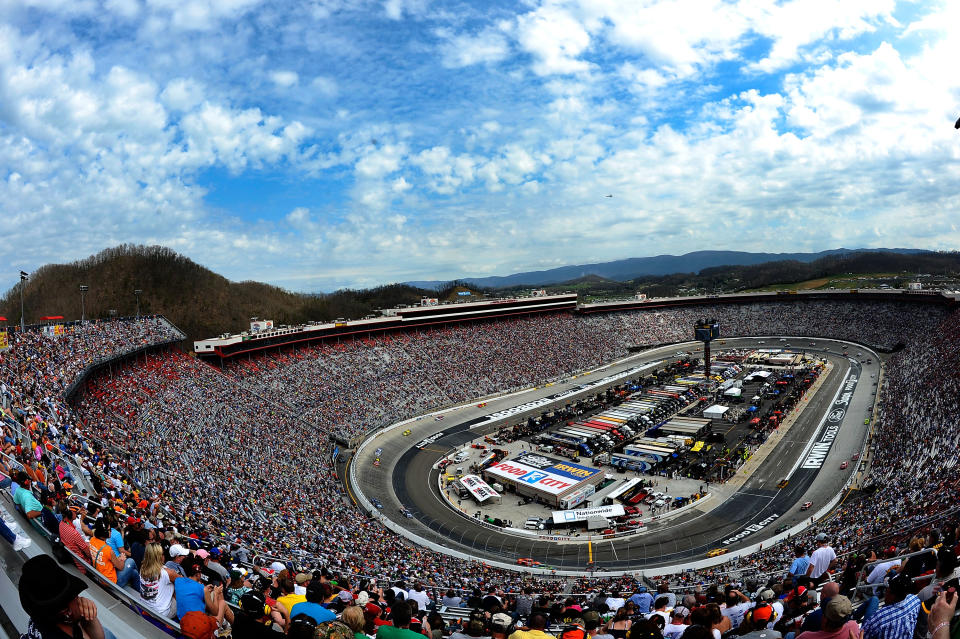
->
<box><xmin>0</xmin><ymin>0</ymin><xmax>960</xmax><ymax>291</ymax></box>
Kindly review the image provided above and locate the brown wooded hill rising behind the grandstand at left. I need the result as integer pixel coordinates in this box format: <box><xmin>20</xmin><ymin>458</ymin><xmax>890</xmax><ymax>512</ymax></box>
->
<box><xmin>0</xmin><ymin>245</ymin><xmax>454</xmax><ymax>340</ymax></box>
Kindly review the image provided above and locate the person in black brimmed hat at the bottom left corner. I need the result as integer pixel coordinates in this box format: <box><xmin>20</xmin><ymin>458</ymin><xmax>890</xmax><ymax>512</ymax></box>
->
<box><xmin>17</xmin><ymin>555</ymin><xmax>115</xmax><ymax>639</ymax></box>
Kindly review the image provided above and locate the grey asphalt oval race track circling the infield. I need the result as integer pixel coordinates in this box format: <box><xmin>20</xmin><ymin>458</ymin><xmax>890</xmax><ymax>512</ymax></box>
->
<box><xmin>351</xmin><ymin>338</ymin><xmax>880</xmax><ymax>570</ymax></box>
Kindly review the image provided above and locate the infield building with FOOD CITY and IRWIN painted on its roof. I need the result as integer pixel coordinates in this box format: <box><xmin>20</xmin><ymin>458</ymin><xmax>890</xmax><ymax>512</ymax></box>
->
<box><xmin>483</xmin><ymin>452</ymin><xmax>604</xmax><ymax>510</ymax></box>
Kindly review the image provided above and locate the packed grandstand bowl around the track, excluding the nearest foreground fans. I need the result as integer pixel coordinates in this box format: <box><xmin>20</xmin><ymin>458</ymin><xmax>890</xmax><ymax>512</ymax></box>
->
<box><xmin>0</xmin><ymin>300</ymin><xmax>960</xmax><ymax>639</ymax></box>
